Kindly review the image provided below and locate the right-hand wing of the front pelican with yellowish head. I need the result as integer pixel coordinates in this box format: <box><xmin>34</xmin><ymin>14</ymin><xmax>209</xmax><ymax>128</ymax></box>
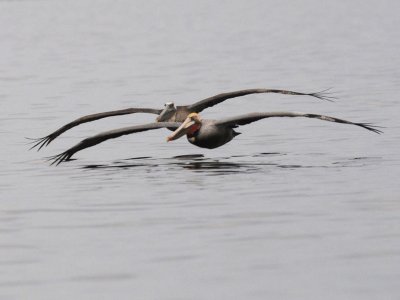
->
<box><xmin>215</xmin><ymin>112</ymin><xmax>382</xmax><ymax>134</ymax></box>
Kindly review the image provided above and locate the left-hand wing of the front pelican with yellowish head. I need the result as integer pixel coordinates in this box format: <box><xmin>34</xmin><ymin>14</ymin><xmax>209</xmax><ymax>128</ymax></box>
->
<box><xmin>45</xmin><ymin>122</ymin><xmax>181</xmax><ymax>165</ymax></box>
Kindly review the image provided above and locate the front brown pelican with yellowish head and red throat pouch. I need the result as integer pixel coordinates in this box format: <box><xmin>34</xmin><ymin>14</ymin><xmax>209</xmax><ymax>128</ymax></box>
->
<box><xmin>49</xmin><ymin>112</ymin><xmax>382</xmax><ymax>165</ymax></box>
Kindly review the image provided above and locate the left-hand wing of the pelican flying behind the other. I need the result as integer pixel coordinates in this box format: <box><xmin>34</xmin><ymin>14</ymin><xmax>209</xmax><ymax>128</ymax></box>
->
<box><xmin>30</xmin><ymin>108</ymin><xmax>162</xmax><ymax>151</ymax></box>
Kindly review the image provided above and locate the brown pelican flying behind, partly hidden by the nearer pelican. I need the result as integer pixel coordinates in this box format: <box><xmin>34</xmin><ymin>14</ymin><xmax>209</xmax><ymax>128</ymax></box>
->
<box><xmin>31</xmin><ymin>89</ymin><xmax>335</xmax><ymax>151</ymax></box>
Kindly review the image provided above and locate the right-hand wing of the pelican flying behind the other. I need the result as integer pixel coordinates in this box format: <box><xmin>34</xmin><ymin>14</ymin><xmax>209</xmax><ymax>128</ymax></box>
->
<box><xmin>187</xmin><ymin>89</ymin><xmax>335</xmax><ymax>113</ymax></box>
